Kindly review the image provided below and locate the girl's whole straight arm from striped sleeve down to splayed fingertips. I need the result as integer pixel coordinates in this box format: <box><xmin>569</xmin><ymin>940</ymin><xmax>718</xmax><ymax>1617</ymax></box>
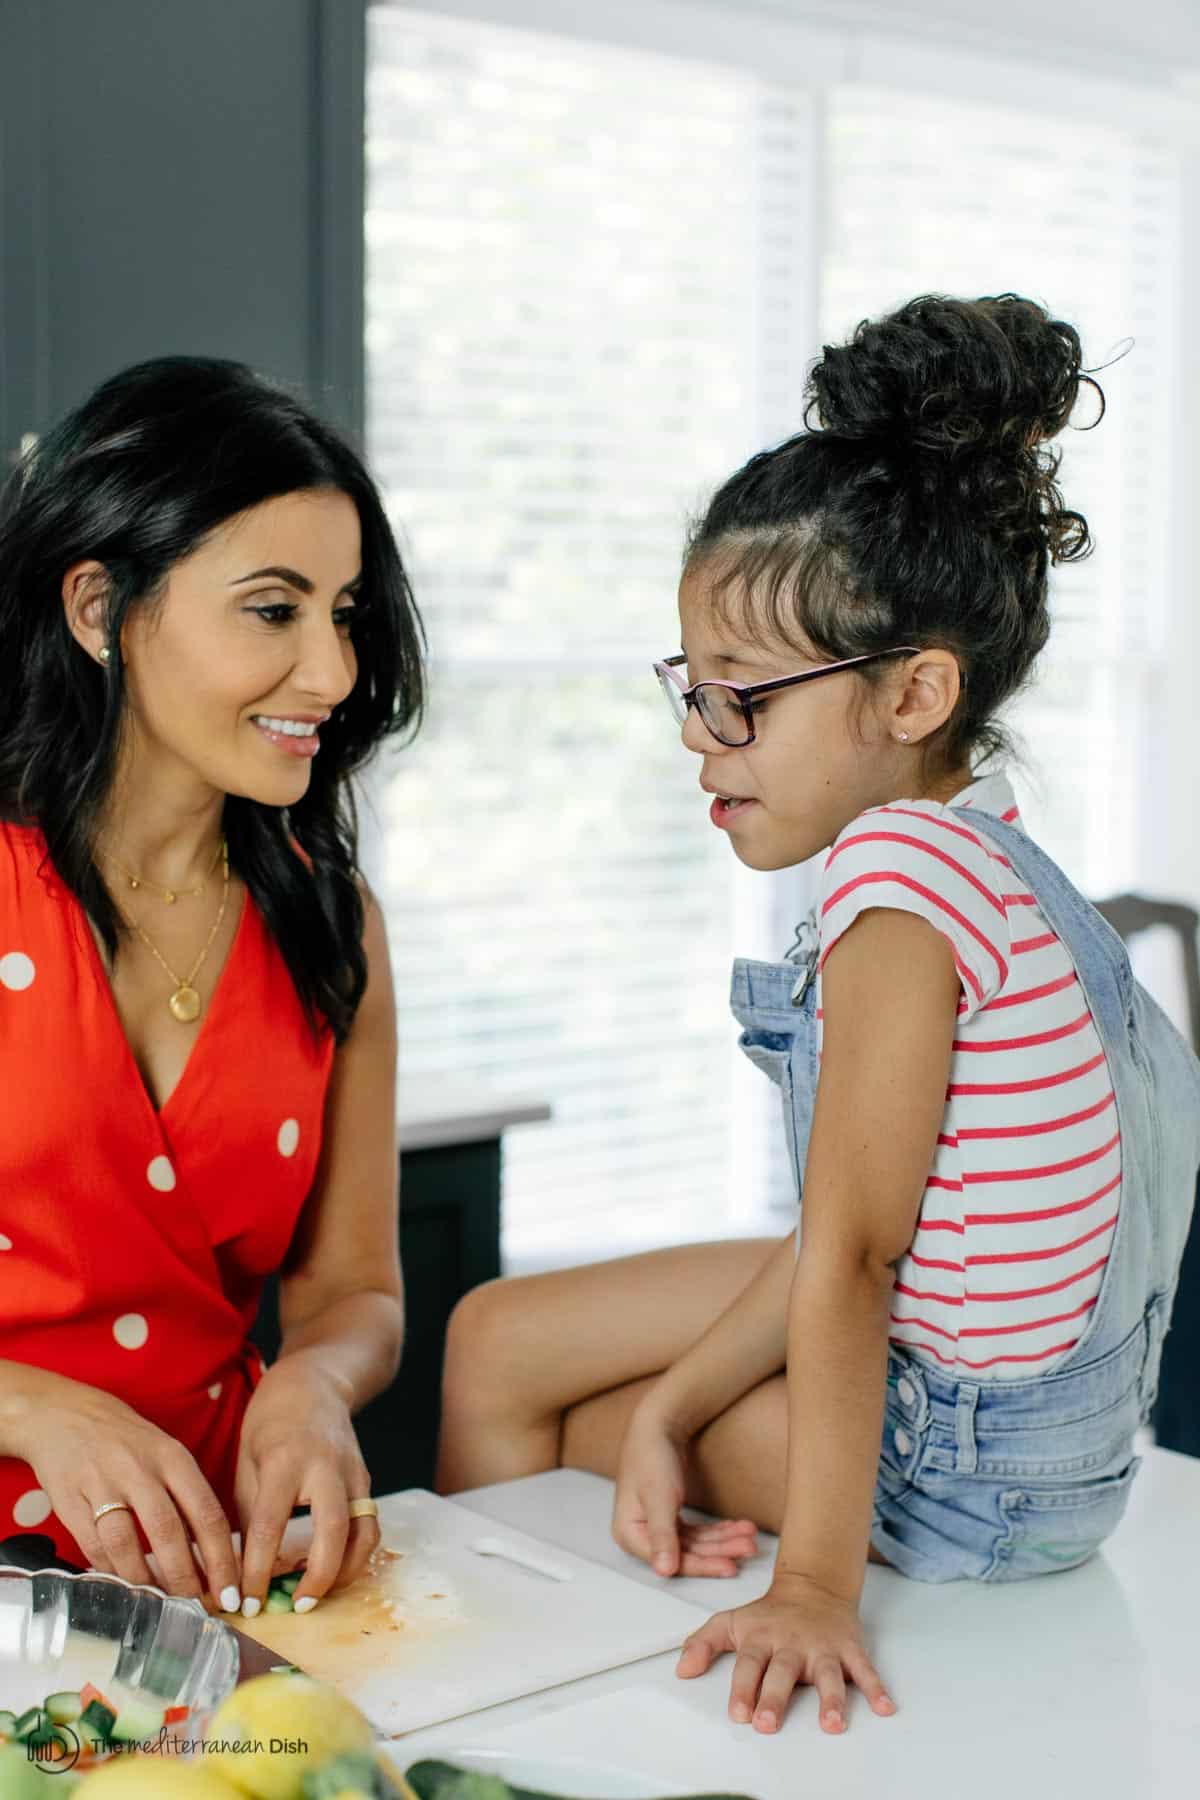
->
<box><xmin>678</xmin><ymin>909</ymin><xmax>959</xmax><ymax>1732</ymax></box>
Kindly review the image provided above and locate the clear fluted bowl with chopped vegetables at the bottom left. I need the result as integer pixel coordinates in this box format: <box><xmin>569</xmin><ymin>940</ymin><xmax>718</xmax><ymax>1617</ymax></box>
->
<box><xmin>0</xmin><ymin>1566</ymin><xmax>237</xmax><ymax>1739</ymax></box>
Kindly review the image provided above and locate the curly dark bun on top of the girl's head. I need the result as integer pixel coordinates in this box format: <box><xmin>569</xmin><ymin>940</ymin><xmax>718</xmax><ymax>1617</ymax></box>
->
<box><xmin>804</xmin><ymin>293</ymin><xmax>1105</xmax><ymax>562</ymax></box>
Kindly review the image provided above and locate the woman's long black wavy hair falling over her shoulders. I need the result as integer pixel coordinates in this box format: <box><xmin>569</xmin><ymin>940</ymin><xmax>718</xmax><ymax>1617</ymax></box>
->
<box><xmin>0</xmin><ymin>356</ymin><xmax>425</xmax><ymax>1042</ymax></box>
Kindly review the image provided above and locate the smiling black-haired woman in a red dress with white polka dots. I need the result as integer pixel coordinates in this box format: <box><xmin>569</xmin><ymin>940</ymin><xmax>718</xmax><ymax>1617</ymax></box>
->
<box><xmin>0</xmin><ymin>356</ymin><xmax>423</xmax><ymax>1616</ymax></box>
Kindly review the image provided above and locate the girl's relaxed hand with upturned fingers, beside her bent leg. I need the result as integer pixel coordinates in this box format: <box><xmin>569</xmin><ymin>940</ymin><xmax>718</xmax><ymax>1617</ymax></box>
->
<box><xmin>612</xmin><ymin>1408</ymin><xmax>757</xmax><ymax>1575</ymax></box>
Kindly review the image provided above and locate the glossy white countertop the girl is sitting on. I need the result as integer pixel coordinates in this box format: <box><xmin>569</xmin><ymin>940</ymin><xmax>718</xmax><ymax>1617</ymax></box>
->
<box><xmin>390</xmin><ymin>1451</ymin><xmax>1200</xmax><ymax>1800</ymax></box>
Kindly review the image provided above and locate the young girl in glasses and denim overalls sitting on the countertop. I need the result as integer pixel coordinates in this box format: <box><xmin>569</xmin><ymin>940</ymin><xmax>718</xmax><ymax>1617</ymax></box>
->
<box><xmin>441</xmin><ymin>295</ymin><xmax>1200</xmax><ymax>1732</ymax></box>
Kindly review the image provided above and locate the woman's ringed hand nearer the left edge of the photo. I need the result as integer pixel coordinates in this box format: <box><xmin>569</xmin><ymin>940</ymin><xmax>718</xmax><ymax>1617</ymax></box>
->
<box><xmin>22</xmin><ymin>1373</ymin><xmax>241</xmax><ymax>1613</ymax></box>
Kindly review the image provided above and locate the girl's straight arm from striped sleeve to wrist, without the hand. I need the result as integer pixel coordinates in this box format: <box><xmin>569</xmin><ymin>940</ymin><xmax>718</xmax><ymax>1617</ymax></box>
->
<box><xmin>777</xmin><ymin>909</ymin><xmax>959</xmax><ymax>1600</ymax></box>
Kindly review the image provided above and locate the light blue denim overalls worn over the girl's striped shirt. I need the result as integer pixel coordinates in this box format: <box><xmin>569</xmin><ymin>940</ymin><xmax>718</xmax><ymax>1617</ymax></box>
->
<box><xmin>730</xmin><ymin>806</ymin><xmax>1200</xmax><ymax>1580</ymax></box>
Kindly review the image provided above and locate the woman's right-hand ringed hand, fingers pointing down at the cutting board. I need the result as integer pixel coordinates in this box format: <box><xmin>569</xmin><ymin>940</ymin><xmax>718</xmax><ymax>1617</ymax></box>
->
<box><xmin>236</xmin><ymin>1352</ymin><xmax>380</xmax><ymax>1618</ymax></box>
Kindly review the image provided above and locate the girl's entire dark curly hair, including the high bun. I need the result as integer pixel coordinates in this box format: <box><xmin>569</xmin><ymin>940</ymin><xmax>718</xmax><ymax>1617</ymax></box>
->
<box><xmin>685</xmin><ymin>293</ymin><xmax>1105</xmax><ymax>770</ymax></box>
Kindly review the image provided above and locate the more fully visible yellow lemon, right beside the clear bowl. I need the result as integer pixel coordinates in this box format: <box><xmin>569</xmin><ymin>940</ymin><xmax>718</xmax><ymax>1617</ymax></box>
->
<box><xmin>205</xmin><ymin>1674</ymin><xmax>374</xmax><ymax>1800</ymax></box>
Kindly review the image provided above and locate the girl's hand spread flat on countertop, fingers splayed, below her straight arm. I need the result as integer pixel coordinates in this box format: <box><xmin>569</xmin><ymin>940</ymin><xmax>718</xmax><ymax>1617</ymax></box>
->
<box><xmin>675</xmin><ymin>1573</ymin><xmax>896</xmax><ymax>1732</ymax></box>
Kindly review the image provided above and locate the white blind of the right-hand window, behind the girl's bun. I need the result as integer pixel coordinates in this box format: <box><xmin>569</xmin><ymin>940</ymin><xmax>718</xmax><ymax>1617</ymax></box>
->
<box><xmin>822</xmin><ymin>85</ymin><xmax>1178</xmax><ymax>898</ymax></box>
